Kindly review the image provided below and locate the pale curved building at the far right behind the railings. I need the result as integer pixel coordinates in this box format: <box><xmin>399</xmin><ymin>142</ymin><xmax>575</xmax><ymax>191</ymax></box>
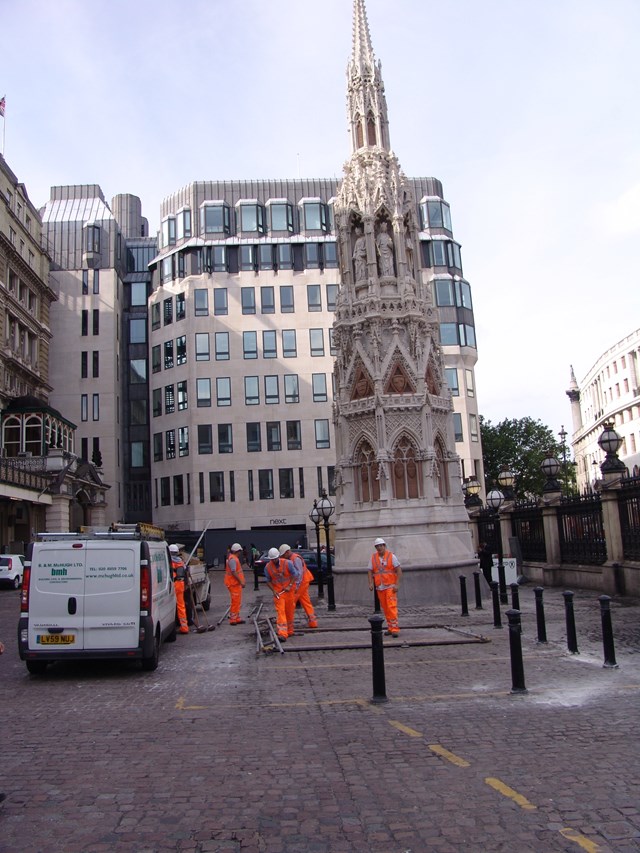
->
<box><xmin>567</xmin><ymin>329</ymin><xmax>640</xmax><ymax>491</ymax></box>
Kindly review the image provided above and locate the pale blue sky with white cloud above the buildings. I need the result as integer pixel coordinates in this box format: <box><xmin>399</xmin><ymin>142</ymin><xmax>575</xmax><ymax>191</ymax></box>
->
<box><xmin>0</xmin><ymin>0</ymin><xmax>640</xmax><ymax>440</ymax></box>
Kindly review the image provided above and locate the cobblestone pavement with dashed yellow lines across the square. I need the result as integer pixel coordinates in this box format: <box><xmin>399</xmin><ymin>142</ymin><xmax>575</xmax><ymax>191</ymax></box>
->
<box><xmin>0</xmin><ymin>578</ymin><xmax>640</xmax><ymax>853</ymax></box>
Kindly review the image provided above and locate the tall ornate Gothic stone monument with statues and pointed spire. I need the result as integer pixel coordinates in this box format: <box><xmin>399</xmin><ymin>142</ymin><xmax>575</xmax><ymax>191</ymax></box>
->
<box><xmin>334</xmin><ymin>0</ymin><xmax>474</xmax><ymax>601</ymax></box>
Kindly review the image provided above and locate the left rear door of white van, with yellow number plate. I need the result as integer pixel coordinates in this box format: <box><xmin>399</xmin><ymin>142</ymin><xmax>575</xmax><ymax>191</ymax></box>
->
<box><xmin>28</xmin><ymin>540</ymin><xmax>85</xmax><ymax>654</ymax></box>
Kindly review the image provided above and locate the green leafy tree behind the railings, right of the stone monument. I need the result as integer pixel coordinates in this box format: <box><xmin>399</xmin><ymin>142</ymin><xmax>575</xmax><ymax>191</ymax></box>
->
<box><xmin>480</xmin><ymin>415</ymin><xmax>575</xmax><ymax>498</ymax></box>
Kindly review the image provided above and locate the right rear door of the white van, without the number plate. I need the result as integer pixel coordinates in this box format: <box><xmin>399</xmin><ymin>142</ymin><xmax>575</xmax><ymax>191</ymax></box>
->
<box><xmin>84</xmin><ymin>539</ymin><xmax>140</xmax><ymax>649</ymax></box>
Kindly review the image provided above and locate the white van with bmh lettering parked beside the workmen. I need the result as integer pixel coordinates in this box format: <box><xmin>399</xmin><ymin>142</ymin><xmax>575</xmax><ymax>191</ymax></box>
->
<box><xmin>18</xmin><ymin>525</ymin><xmax>176</xmax><ymax>675</ymax></box>
